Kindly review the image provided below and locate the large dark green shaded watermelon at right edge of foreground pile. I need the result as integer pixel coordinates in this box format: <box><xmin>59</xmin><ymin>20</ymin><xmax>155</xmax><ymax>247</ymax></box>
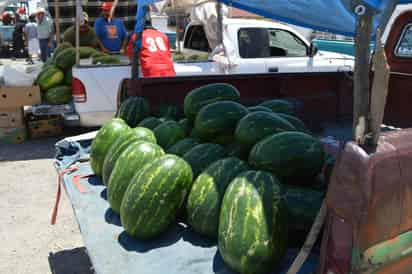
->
<box><xmin>249</xmin><ymin>132</ymin><xmax>325</xmax><ymax>185</ymax></box>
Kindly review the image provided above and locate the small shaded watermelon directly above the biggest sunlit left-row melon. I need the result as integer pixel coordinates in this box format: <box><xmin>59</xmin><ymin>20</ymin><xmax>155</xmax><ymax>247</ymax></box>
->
<box><xmin>153</xmin><ymin>121</ymin><xmax>185</xmax><ymax>150</ymax></box>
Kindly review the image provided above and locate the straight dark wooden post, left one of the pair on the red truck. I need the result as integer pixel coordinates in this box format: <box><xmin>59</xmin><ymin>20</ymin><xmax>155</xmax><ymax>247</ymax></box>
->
<box><xmin>353</xmin><ymin>13</ymin><xmax>372</xmax><ymax>144</ymax></box>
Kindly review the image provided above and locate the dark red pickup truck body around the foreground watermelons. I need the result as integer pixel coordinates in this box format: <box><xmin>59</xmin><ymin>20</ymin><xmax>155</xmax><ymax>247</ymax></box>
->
<box><xmin>118</xmin><ymin>11</ymin><xmax>412</xmax><ymax>274</ymax></box>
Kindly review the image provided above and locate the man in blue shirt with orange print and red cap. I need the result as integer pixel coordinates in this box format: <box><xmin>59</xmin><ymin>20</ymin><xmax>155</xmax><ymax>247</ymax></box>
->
<box><xmin>94</xmin><ymin>2</ymin><xmax>127</xmax><ymax>53</ymax></box>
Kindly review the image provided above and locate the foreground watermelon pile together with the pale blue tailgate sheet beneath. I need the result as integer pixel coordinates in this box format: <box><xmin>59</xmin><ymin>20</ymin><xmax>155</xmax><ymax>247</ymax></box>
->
<box><xmin>54</xmin><ymin>83</ymin><xmax>340</xmax><ymax>274</ymax></box>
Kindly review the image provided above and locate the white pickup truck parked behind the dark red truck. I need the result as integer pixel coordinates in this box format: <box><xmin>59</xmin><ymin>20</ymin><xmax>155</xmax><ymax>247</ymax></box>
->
<box><xmin>65</xmin><ymin>18</ymin><xmax>354</xmax><ymax>127</ymax></box>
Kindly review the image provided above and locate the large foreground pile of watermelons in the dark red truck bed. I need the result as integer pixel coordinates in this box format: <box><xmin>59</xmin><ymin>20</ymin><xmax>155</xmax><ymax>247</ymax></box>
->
<box><xmin>91</xmin><ymin>83</ymin><xmax>325</xmax><ymax>274</ymax></box>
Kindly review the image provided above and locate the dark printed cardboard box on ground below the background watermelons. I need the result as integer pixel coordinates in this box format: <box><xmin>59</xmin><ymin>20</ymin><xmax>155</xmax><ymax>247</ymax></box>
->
<box><xmin>27</xmin><ymin>116</ymin><xmax>63</xmax><ymax>138</ymax></box>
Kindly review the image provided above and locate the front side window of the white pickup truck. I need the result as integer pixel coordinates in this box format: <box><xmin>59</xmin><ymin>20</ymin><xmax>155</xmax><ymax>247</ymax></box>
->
<box><xmin>238</xmin><ymin>28</ymin><xmax>307</xmax><ymax>58</ymax></box>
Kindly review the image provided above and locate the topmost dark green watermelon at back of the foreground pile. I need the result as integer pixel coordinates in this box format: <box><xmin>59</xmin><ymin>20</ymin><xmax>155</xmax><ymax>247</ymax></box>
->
<box><xmin>184</xmin><ymin>83</ymin><xmax>240</xmax><ymax>121</ymax></box>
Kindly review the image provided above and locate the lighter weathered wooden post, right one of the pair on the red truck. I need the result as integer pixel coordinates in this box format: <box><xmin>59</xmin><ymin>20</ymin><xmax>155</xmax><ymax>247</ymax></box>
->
<box><xmin>370</xmin><ymin>30</ymin><xmax>390</xmax><ymax>145</ymax></box>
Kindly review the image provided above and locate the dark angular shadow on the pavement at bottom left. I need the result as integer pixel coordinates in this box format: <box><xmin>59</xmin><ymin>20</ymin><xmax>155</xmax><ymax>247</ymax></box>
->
<box><xmin>49</xmin><ymin>247</ymin><xmax>94</xmax><ymax>274</ymax></box>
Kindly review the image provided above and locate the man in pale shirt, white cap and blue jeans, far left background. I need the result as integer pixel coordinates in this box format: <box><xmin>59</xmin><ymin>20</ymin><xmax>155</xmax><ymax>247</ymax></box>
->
<box><xmin>37</xmin><ymin>8</ymin><xmax>53</xmax><ymax>62</ymax></box>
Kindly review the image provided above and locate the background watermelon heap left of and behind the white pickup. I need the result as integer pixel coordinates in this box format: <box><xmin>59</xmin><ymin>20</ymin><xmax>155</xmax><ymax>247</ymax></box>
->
<box><xmin>36</xmin><ymin>43</ymin><xmax>120</xmax><ymax>105</ymax></box>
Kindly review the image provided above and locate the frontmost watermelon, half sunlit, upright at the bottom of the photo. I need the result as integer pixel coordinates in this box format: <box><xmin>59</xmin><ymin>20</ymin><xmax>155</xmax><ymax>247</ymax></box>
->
<box><xmin>218</xmin><ymin>171</ymin><xmax>287</xmax><ymax>274</ymax></box>
